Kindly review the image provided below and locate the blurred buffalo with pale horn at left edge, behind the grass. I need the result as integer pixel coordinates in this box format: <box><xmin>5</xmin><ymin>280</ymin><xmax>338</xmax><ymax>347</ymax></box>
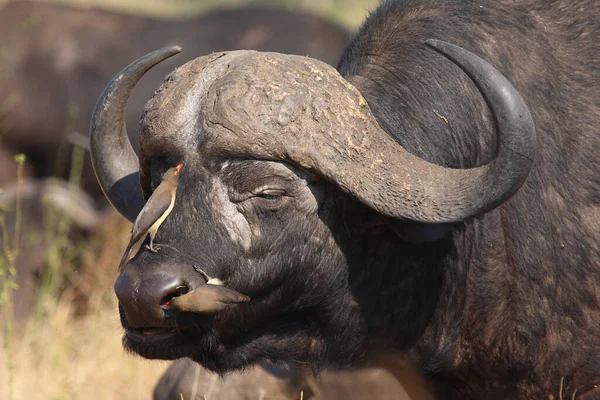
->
<box><xmin>0</xmin><ymin>178</ymin><xmax>114</xmax><ymax>323</ymax></box>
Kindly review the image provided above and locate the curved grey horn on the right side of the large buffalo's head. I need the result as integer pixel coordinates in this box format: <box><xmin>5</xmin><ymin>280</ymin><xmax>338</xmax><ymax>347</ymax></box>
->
<box><xmin>331</xmin><ymin>40</ymin><xmax>535</xmax><ymax>223</ymax></box>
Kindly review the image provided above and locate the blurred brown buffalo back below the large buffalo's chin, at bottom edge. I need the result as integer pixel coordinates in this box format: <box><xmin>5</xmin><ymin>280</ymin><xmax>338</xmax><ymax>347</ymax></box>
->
<box><xmin>153</xmin><ymin>358</ymin><xmax>432</xmax><ymax>400</ymax></box>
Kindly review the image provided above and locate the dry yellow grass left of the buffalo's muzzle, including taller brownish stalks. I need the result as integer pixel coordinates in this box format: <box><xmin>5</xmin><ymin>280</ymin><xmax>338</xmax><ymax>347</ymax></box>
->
<box><xmin>0</xmin><ymin>216</ymin><xmax>173</xmax><ymax>400</ymax></box>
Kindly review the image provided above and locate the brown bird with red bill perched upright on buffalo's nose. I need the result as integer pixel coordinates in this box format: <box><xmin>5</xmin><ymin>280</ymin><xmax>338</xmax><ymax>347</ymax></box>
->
<box><xmin>119</xmin><ymin>164</ymin><xmax>183</xmax><ymax>269</ymax></box>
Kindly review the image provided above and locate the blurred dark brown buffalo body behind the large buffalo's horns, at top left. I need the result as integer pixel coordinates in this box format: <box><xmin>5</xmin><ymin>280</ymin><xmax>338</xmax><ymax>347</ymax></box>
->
<box><xmin>0</xmin><ymin>2</ymin><xmax>349</xmax><ymax>197</ymax></box>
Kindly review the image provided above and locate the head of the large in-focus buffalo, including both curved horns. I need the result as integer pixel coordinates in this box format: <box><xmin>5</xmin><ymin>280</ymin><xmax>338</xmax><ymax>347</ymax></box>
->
<box><xmin>91</xmin><ymin>41</ymin><xmax>534</xmax><ymax>371</ymax></box>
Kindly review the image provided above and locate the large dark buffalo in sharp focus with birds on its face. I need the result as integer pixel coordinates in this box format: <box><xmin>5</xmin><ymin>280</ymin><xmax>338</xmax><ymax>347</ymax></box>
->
<box><xmin>90</xmin><ymin>0</ymin><xmax>600</xmax><ymax>399</ymax></box>
